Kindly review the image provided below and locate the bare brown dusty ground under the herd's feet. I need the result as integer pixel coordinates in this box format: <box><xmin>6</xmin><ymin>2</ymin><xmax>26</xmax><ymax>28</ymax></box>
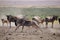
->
<box><xmin>0</xmin><ymin>24</ymin><xmax>60</xmax><ymax>40</ymax></box>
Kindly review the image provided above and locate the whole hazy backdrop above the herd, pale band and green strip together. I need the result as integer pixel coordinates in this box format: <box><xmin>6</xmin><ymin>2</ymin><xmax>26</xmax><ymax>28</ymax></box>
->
<box><xmin>0</xmin><ymin>0</ymin><xmax>60</xmax><ymax>17</ymax></box>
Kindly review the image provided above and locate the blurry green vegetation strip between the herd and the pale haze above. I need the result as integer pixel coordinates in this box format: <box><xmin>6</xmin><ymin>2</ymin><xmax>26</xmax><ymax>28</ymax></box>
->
<box><xmin>0</xmin><ymin>7</ymin><xmax>60</xmax><ymax>18</ymax></box>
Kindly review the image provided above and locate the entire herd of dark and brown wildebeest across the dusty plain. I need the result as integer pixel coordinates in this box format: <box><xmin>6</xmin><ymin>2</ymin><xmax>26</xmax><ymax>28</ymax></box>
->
<box><xmin>1</xmin><ymin>15</ymin><xmax>60</xmax><ymax>31</ymax></box>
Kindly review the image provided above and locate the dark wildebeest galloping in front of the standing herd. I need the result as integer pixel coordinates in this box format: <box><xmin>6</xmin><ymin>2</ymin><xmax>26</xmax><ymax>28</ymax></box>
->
<box><xmin>15</xmin><ymin>19</ymin><xmax>39</xmax><ymax>31</ymax></box>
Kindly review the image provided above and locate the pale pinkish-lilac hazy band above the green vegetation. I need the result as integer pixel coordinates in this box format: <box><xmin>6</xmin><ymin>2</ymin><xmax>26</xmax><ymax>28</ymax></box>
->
<box><xmin>0</xmin><ymin>0</ymin><xmax>60</xmax><ymax>7</ymax></box>
